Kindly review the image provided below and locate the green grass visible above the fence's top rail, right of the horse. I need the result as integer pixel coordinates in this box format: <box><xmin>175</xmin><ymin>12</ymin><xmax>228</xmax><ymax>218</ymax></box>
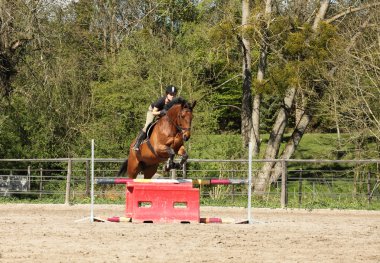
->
<box><xmin>191</xmin><ymin>133</ymin><xmax>380</xmax><ymax>160</ymax></box>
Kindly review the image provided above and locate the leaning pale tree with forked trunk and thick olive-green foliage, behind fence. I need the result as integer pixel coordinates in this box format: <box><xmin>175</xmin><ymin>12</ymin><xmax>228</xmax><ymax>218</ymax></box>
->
<box><xmin>251</xmin><ymin>0</ymin><xmax>375</xmax><ymax>192</ymax></box>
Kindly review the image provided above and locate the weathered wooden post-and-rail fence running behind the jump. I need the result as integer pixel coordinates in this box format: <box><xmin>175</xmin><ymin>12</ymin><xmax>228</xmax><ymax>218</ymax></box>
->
<box><xmin>0</xmin><ymin>158</ymin><xmax>380</xmax><ymax>207</ymax></box>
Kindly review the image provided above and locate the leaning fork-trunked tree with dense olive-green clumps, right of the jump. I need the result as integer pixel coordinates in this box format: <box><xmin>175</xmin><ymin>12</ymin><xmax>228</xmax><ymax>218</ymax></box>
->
<box><xmin>255</xmin><ymin>0</ymin><xmax>380</xmax><ymax>193</ymax></box>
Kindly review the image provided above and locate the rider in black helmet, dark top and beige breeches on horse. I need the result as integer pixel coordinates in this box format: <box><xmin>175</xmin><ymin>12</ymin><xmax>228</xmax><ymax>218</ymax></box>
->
<box><xmin>133</xmin><ymin>85</ymin><xmax>177</xmax><ymax>151</ymax></box>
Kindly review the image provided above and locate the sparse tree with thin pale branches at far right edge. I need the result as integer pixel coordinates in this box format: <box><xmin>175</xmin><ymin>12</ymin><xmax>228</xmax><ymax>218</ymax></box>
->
<box><xmin>323</xmin><ymin>4</ymin><xmax>380</xmax><ymax>158</ymax></box>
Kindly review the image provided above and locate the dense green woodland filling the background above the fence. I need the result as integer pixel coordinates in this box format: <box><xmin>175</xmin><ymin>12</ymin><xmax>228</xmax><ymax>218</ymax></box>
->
<box><xmin>0</xmin><ymin>0</ymin><xmax>380</xmax><ymax>169</ymax></box>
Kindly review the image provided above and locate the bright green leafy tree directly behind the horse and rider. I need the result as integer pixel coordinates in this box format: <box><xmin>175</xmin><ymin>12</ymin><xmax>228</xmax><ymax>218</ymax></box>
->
<box><xmin>86</xmin><ymin>31</ymin><xmax>212</xmax><ymax>156</ymax></box>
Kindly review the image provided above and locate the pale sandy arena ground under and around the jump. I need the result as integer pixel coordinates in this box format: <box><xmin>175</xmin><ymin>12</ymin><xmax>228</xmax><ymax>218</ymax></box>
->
<box><xmin>0</xmin><ymin>204</ymin><xmax>380</xmax><ymax>263</ymax></box>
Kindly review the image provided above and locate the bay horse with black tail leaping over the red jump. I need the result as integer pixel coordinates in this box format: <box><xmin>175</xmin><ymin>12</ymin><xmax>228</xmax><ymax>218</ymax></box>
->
<box><xmin>118</xmin><ymin>98</ymin><xmax>196</xmax><ymax>179</ymax></box>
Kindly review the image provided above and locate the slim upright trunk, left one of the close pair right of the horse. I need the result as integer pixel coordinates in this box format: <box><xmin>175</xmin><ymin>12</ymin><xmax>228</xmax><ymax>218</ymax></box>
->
<box><xmin>241</xmin><ymin>0</ymin><xmax>252</xmax><ymax>146</ymax></box>
